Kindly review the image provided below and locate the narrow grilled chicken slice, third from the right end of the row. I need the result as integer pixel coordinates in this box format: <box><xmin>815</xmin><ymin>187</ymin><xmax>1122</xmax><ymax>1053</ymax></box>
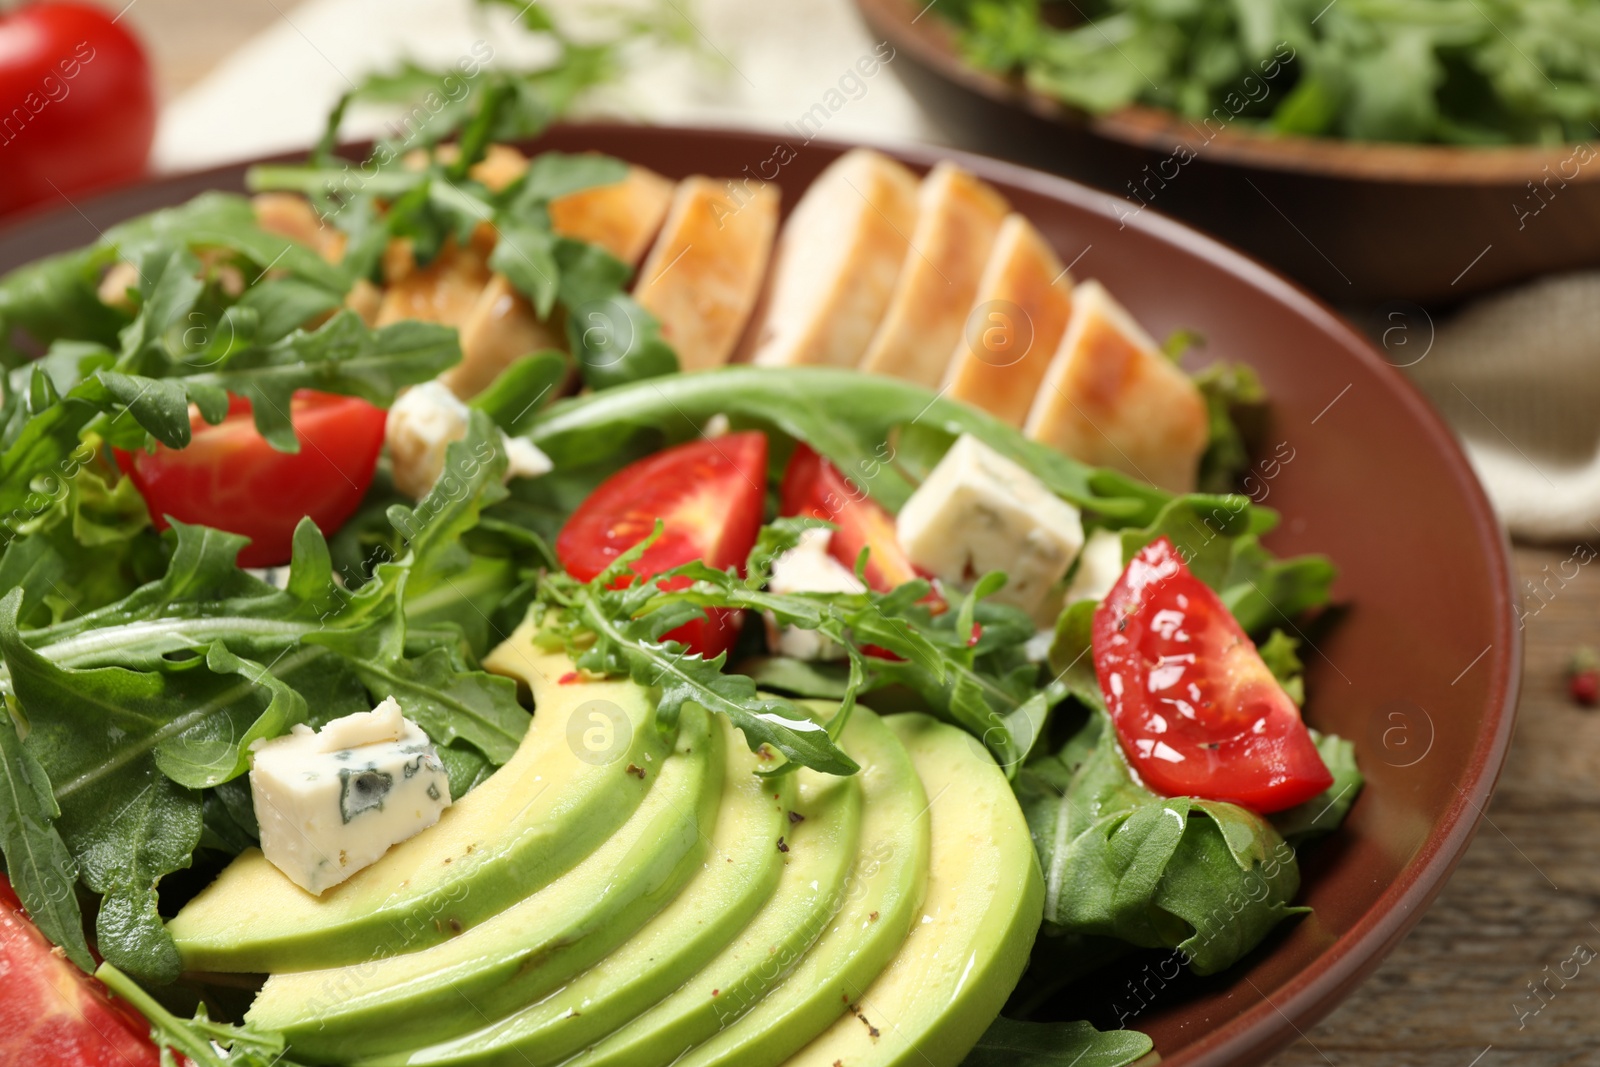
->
<box><xmin>861</xmin><ymin>163</ymin><xmax>1008</xmax><ymax>387</ymax></box>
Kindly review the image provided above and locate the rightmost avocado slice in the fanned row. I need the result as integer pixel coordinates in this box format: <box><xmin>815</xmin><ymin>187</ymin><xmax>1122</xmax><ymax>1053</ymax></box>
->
<box><xmin>789</xmin><ymin>715</ymin><xmax>1045</xmax><ymax>1067</ymax></box>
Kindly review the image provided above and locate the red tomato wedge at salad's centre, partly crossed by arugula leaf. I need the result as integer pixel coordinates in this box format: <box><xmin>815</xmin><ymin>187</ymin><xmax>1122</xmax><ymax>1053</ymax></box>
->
<box><xmin>555</xmin><ymin>432</ymin><xmax>766</xmax><ymax>657</ymax></box>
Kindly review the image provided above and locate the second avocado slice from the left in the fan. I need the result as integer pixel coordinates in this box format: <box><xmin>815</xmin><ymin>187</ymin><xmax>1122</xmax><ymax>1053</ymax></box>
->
<box><xmin>245</xmin><ymin>705</ymin><xmax>726</xmax><ymax>1064</ymax></box>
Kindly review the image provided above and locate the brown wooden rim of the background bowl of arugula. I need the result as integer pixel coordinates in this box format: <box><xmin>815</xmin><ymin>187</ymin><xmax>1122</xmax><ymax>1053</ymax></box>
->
<box><xmin>854</xmin><ymin>0</ymin><xmax>1600</xmax><ymax>187</ymax></box>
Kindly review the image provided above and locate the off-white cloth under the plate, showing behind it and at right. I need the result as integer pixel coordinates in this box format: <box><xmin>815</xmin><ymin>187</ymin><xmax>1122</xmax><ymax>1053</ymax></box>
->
<box><xmin>155</xmin><ymin>0</ymin><xmax>1600</xmax><ymax>539</ymax></box>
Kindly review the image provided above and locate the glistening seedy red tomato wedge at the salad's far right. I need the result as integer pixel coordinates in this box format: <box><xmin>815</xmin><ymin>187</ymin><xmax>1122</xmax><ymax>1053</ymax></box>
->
<box><xmin>1094</xmin><ymin>537</ymin><xmax>1333</xmax><ymax>814</ymax></box>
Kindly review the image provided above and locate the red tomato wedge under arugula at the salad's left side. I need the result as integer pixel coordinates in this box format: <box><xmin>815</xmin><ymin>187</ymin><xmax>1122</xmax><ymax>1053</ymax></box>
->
<box><xmin>117</xmin><ymin>390</ymin><xmax>387</xmax><ymax>566</ymax></box>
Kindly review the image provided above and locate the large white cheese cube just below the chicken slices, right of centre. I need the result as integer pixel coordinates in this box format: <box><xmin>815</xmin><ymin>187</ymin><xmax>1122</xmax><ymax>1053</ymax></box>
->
<box><xmin>896</xmin><ymin>434</ymin><xmax>1083</xmax><ymax>625</ymax></box>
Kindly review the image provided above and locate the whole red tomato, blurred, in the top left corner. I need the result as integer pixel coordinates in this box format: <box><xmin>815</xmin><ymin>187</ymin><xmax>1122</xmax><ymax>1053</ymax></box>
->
<box><xmin>0</xmin><ymin>0</ymin><xmax>155</xmax><ymax>214</ymax></box>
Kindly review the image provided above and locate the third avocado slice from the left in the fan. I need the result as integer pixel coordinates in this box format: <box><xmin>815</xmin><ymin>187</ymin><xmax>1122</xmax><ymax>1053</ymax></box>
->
<box><xmin>350</xmin><ymin>709</ymin><xmax>800</xmax><ymax>1067</ymax></box>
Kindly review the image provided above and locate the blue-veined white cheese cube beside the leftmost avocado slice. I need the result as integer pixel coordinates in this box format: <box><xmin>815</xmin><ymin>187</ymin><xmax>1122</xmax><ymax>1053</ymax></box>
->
<box><xmin>250</xmin><ymin>697</ymin><xmax>450</xmax><ymax>894</ymax></box>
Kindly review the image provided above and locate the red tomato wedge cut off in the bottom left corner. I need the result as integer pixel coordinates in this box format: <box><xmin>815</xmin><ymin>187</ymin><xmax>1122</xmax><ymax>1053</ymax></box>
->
<box><xmin>0</xmin><ymin>875</ymin><xmax>160</xmax><ymax>1067</ymax></box>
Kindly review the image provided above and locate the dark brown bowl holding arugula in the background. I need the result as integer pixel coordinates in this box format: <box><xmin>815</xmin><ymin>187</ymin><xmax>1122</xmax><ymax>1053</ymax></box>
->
<box><xmin>856</xmin><ymin>0</ymin><xmax>1600</xmax><ymax>306</ymax></box>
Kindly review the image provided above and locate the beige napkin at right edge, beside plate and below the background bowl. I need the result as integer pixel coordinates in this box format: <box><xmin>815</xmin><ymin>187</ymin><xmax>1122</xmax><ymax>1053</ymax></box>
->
<box><xmin>1408</xmin><ymin>272</ymin><xmax>1600</xmax><ymax>541</ymax></box>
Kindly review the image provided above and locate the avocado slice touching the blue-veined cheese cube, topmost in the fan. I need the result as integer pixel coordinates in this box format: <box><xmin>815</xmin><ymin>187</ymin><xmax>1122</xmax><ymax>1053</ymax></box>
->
<box><xmin>166</xmin><ymin>622</ymin><xmax>672</xmax><ymax>973</ymax></box>
